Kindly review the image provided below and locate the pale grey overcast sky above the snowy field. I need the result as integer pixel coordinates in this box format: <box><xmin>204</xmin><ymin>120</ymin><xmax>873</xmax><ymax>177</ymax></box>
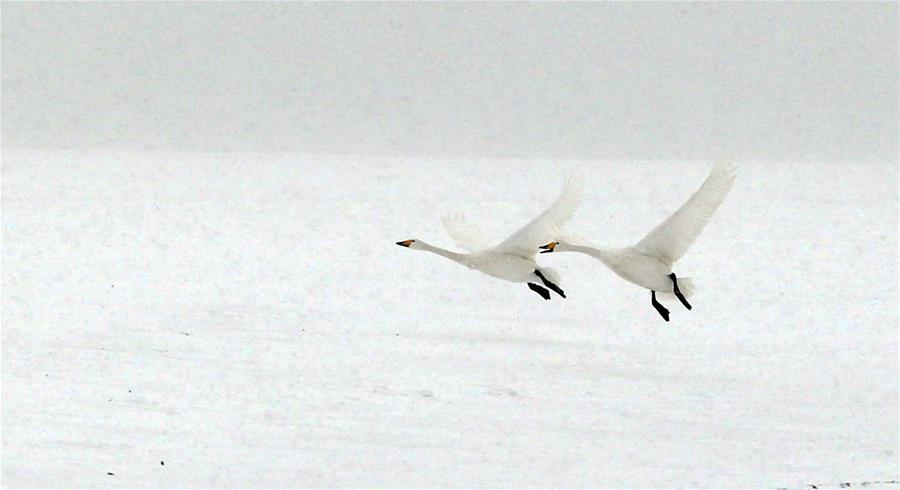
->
<box><xmin>2</xmin><ymin>2</ymin><xmax>900</xmax><ymax>162</ymax></box>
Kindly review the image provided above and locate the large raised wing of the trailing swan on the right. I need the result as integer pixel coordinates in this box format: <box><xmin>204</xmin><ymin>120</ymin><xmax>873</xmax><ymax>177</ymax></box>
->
<box><xmin>634</xmin><ymin>158</ymin><xmax>734</xmax><ymax>264</ymax></box>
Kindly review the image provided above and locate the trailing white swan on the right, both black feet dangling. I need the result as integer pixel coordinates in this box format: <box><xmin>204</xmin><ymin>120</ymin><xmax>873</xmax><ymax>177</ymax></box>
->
<box><xmin>540</xmin><ymin>161</ymin><xmax>734</xmax><ymax>321</ymax></box>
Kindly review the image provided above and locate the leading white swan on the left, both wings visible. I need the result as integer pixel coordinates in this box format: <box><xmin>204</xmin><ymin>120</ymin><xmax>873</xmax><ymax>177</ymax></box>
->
<box><xmin>397</xmin><ymin>178</ymin><xmax>581</xmax><ymax>300</ymax></box>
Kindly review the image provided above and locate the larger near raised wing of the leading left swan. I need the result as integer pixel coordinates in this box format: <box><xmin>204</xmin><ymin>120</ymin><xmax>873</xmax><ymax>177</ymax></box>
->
<box><xmin>496</xmin><ymin>177</ymin><xmax>581</xmax><ymax>258</ymax></box>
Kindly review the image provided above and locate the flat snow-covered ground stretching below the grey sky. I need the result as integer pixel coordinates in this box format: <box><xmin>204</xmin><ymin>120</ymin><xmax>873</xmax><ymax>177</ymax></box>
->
<box><xmin>2</xmin><ymin>151</ymin><xmax>900</xmax><ymax>488</ymax></box>
